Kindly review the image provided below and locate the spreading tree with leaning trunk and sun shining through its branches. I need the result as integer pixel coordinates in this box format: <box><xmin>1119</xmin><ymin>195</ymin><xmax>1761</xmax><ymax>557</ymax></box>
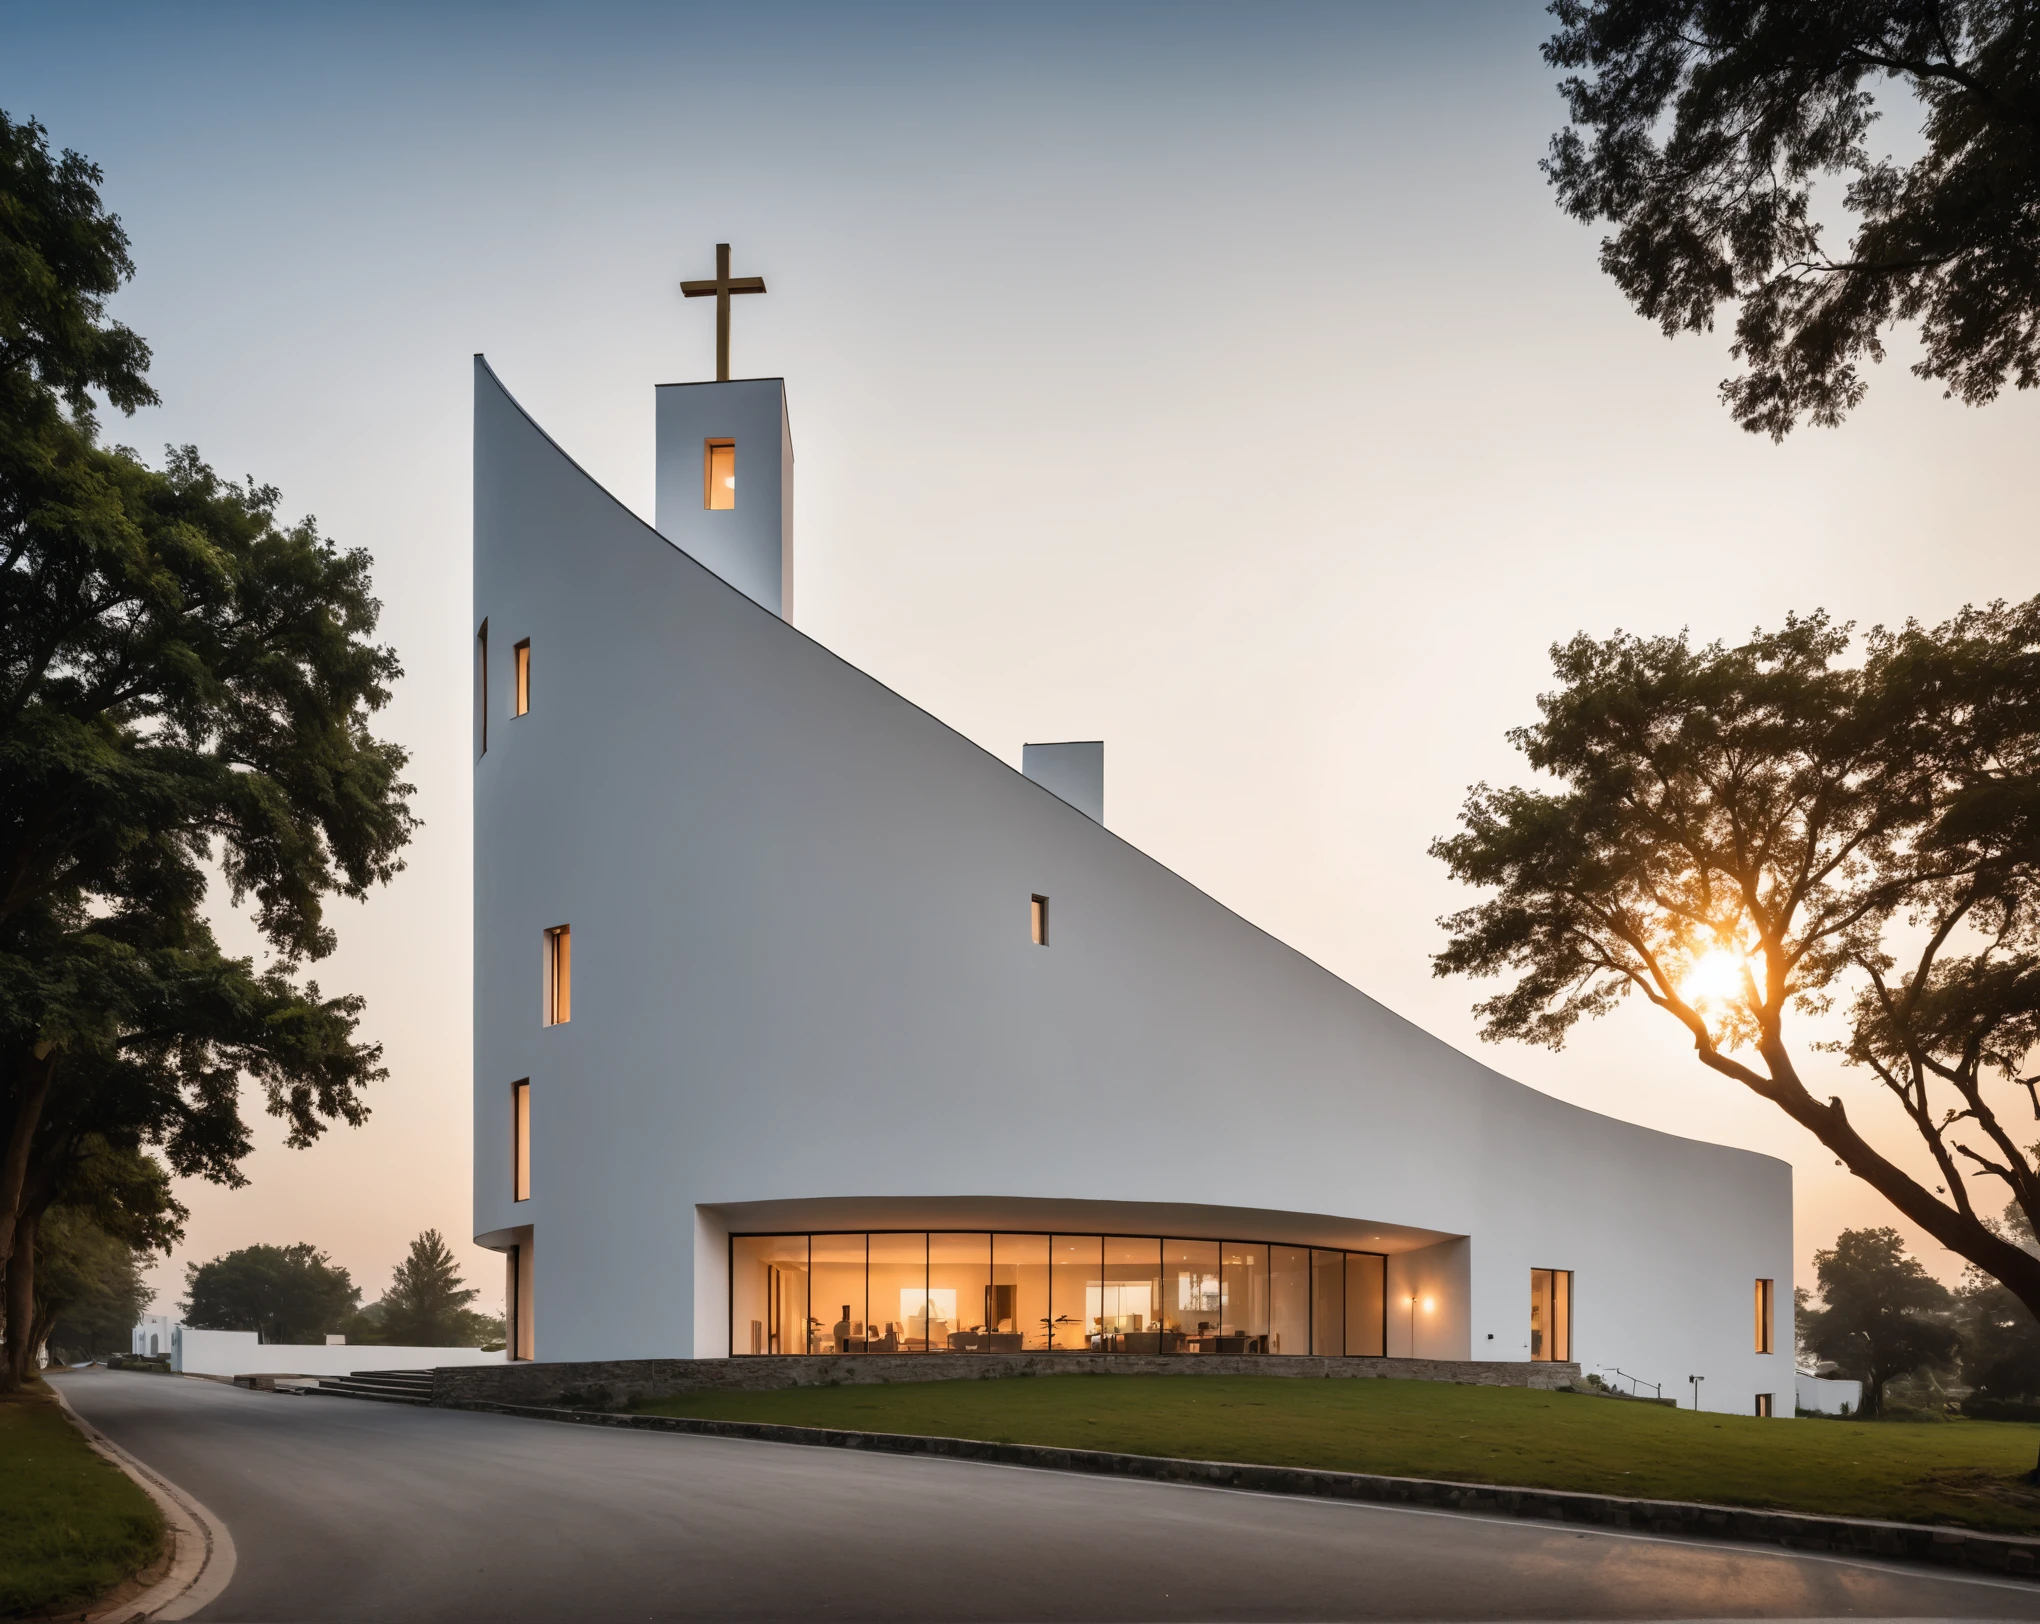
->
<box><xmin>1432</xmin><ymin>600</ymin><xmax>2040</xmax><ymax>1312</ymax></box>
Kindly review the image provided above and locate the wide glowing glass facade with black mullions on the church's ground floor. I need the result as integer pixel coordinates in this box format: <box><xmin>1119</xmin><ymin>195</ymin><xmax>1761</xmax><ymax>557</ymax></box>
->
<box><xmin>730</xmin><ymin>1230</ymin><xmax>1387</xmax><ymax>1357</ymax></box>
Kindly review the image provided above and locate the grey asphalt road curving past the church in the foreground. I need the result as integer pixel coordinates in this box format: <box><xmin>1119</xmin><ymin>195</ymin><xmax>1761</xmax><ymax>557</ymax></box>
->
<box><xmin>57</xmin><ymin>1371</ymin><xmax>2040</xmax><ymax>1624</ymax></box>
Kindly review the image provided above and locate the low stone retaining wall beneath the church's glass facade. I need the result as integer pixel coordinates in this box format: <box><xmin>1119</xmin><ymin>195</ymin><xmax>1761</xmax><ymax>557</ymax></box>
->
<box><xmin>432</xmin><ymin>1353</ymin><xmax>1581</xmax><ymax>1410</ymax></box>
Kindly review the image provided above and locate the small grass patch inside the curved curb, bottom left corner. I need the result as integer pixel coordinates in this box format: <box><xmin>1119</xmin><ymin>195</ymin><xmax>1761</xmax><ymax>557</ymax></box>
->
<box><xmin>0</xmin><ymin>1389</ymin><xmax>163</xmax><ymax>1616</ymax></box>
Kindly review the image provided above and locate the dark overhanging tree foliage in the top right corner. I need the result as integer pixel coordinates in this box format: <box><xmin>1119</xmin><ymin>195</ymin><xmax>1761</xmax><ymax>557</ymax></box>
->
<box><xmin>1542</xmin><ymin>0</ymin><xmax>2040</xmax><ymax>439</ymax></box>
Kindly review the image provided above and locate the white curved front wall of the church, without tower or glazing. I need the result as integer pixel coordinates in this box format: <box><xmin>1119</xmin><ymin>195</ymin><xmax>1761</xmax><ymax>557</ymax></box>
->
<box><xmin>475</xmin><ymin>357</ymin><xmax>1793</xmax><ymax>1414</ymax></box>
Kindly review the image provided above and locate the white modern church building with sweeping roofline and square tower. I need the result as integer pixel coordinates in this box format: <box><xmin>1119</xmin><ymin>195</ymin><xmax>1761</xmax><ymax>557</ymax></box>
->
<box><xmin>473</xmin><ymin>326</ymin><xmax>1793</xmax><ymax>1416</ymax></box>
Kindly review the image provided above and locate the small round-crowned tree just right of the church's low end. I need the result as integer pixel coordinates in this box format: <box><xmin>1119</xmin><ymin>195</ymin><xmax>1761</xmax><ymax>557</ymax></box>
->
<box><xmin>1805</xmin><ymin>1230</ymin><xmax>1960</xmax><ymax>1416</ymax></box>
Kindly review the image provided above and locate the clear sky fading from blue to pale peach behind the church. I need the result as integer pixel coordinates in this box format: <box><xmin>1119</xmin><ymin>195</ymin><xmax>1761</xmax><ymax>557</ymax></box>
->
<box><xmin>0</xmin><ymin>0</ymin><xmax>2040</xmax><ymax>1306</ymax></box>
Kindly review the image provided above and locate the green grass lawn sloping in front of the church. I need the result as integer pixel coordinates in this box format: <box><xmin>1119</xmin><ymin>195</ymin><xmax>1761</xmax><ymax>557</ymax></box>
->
<box><xmin>639</xmin><ymin>1375</ymin><xmax>2040</xmax><ymax>1532</ymax></box>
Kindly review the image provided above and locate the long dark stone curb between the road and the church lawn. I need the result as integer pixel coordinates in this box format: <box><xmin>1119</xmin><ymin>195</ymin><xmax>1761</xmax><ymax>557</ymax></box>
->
<box><xmin>446</xmin><ymin>1400</ymin><xmax>2040</xmax><ymax>1577</ymax></box>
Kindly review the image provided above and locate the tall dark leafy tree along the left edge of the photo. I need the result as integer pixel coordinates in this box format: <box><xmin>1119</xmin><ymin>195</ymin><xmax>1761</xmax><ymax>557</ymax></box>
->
<box><xmin>0</xmin><ymin>114</ymin><xmax>414</xmax><ymax>1389</ymax></box>
